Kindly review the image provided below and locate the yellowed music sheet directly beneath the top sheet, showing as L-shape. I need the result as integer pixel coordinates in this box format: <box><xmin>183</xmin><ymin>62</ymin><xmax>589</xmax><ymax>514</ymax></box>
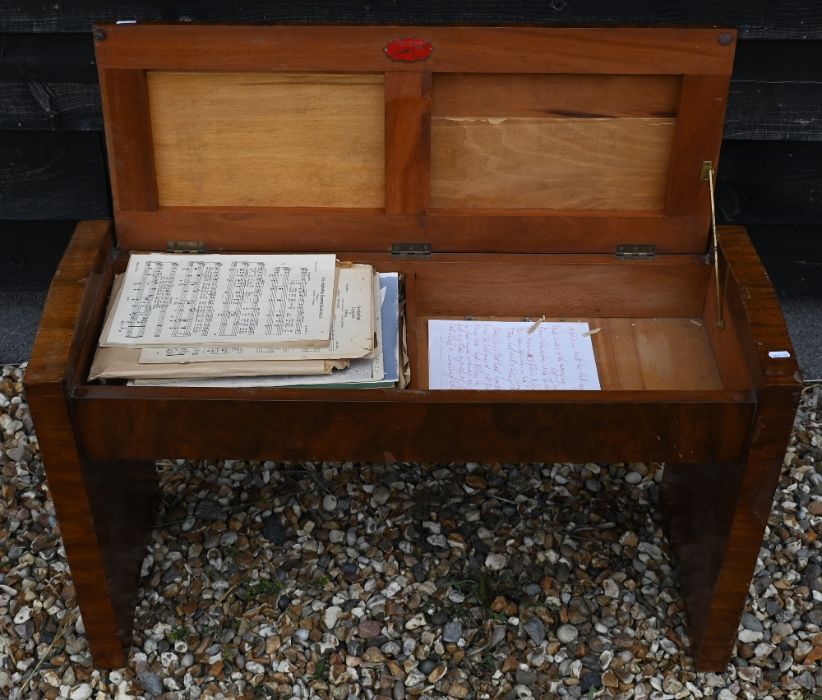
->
<box><xmin>140</xmin><ymin>265</ymin><xmax>377</xmax><ymax>364</ymax></box>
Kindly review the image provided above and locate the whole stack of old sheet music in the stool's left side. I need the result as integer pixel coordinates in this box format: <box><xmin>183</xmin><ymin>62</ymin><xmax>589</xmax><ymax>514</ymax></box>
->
<box><xmin>89</xmin><ymin>253</ymin><xmax>402</xmax><ymax>388</ymax></box>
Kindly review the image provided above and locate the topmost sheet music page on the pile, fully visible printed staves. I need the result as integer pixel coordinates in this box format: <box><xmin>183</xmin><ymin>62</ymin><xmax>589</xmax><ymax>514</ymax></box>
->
<box><xmin>100</xmin><ymin>253</ymin><xmax>336</xmax><ymax>347</ymax></box>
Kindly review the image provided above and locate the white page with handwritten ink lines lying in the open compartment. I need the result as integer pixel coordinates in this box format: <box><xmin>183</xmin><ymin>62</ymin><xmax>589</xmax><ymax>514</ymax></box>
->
<box><xmin>428</xmin><ymin>320</ymin><xmax>600</xmax><ymax>391</ymax></box>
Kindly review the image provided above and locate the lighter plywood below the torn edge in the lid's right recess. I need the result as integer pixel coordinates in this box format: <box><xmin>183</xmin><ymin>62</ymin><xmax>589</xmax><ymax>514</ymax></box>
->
<box><xmin>431</xmin><ymin>117</ymin><xmax>676</xmax><ymax>210</ymax></box>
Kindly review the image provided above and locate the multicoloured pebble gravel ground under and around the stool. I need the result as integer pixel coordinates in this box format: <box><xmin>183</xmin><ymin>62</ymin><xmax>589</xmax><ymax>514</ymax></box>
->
<box><xmin>0</xmin><ymin>366</ymin><xmax>822</xmax><ymax>700</ymax></box>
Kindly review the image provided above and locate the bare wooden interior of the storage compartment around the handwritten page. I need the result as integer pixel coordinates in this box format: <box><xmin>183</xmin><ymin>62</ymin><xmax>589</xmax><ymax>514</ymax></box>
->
<box><xmin>83</xmin><ymin>253</ymin><xmax>751</xmax><ymax>400</ymax></box>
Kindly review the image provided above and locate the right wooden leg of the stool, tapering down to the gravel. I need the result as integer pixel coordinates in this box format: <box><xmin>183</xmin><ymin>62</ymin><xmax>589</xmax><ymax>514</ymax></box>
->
<box><xmin>662</xmin><ymin>392</ymin><xmax>796</xmax><ymax>672</ymax></box>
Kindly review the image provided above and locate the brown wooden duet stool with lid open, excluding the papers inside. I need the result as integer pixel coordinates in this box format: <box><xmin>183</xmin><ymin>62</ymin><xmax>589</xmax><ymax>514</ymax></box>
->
<box><xmin>26</xmin><ymin>25</ymin><xmax>800</xmax><ymax>671</ymax></box>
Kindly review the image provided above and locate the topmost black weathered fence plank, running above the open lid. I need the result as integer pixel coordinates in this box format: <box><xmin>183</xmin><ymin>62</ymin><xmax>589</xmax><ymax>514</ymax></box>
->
<box><xmin>0</xmin><ymin>0</ymin><xmax>822</xmax><ymax>39</ymax></box>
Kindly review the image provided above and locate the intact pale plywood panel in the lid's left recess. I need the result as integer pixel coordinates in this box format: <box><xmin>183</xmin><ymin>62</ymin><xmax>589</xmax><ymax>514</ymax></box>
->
<box><xmin>148</xmin><ymin>72</ymin><xmax>385</xmax><ymax>207</ymax></box>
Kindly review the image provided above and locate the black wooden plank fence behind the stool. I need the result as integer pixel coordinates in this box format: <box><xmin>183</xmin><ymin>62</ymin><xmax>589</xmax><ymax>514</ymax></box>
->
<box><xmin>0</xmin><ymin>0</ymin><xmax>822</xmax><ymax>296</ymax></box>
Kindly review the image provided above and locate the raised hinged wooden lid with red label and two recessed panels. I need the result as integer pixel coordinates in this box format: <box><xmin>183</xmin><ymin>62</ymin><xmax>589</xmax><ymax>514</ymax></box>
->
<box><xmin>95</xmin><ymin>24</ymin><xmax>736</xmax><ymax>253</ymax></box>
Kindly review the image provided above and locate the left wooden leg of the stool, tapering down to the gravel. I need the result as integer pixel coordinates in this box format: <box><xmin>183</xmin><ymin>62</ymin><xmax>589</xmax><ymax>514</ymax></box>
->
<box><xmin>29</xmin><ymin>385</ymin><xmax>158</xmax><ymax>668</ymax></box>
